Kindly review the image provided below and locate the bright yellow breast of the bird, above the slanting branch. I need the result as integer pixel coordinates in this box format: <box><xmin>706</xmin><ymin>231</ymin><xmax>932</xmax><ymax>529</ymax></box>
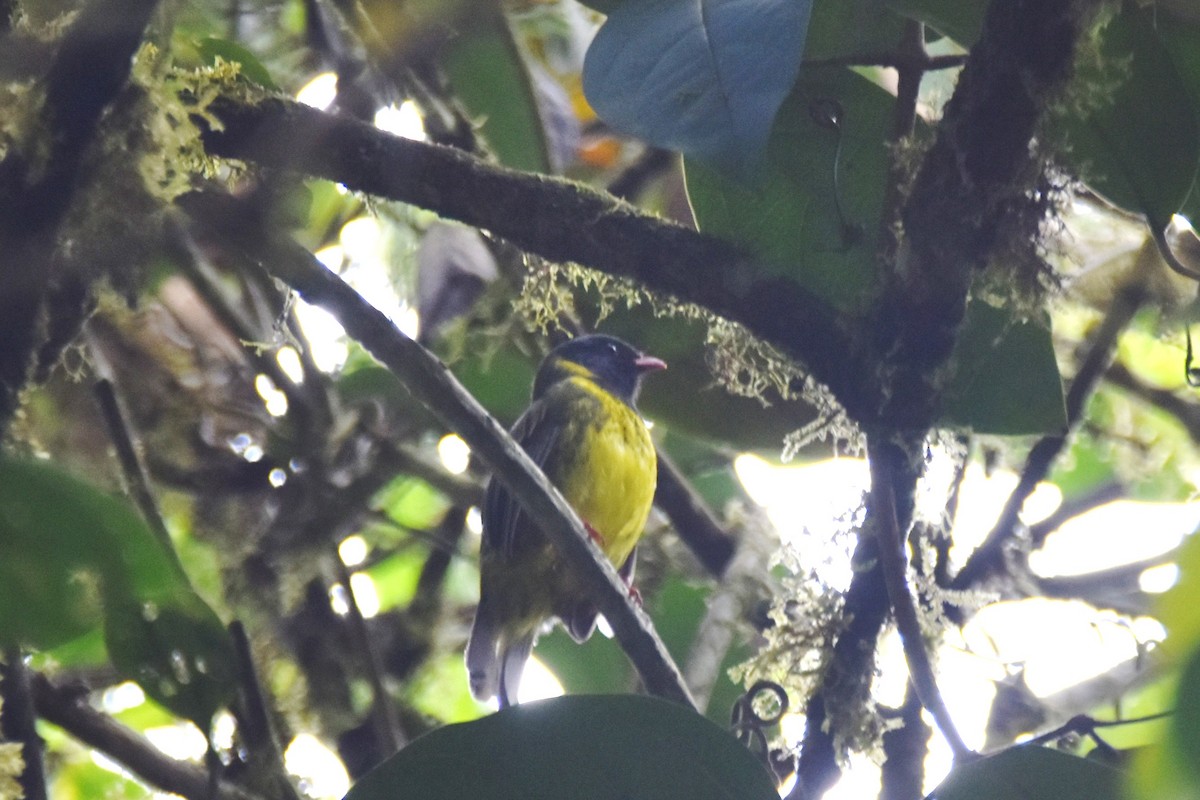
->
<box><xmin>559</xmin><ymin>378</ymin><xmax>658</xmax><ymax>567</ymax></box>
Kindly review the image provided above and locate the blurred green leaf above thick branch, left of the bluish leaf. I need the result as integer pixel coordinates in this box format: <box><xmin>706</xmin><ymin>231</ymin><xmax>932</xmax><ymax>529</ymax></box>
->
<box><xmin>442</xmin><ymin>5</ymin><xmax>551</xmax><ymax>173</ymax></box>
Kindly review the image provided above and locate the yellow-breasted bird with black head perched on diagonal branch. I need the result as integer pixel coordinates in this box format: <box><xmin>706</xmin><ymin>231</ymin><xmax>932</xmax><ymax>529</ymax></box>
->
<box><xmin>466</xmin><ymin>335</ymin><xmax>666</xmax><ymax>708</ymax></box>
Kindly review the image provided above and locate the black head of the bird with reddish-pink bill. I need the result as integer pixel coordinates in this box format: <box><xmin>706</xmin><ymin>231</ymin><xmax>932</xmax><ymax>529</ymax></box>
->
<box><xmin>533</xmin><ymin>335</ymin><xmax>667</xmax><ymax>405</ymax></box>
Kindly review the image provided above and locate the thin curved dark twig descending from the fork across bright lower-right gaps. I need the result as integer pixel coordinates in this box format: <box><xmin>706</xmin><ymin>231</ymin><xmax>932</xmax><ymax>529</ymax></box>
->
<box><xmin>870</xmin><ymin>447</ymin><xmax>974</xmax><ymax>763</ymax></box>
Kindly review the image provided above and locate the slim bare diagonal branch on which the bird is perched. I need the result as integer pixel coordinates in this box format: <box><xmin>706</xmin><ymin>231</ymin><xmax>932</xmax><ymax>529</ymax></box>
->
<box><xmin>180</xmin><ymin>194</ymin><xmax>695</xmax><ymax>708</ymax></box>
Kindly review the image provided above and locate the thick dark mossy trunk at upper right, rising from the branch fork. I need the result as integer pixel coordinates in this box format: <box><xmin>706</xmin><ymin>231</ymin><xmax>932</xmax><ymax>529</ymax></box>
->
<box><xmin>876</xmin><ymin>0</ymin><xmax>1098</xmax><ymax>431</ymax></box>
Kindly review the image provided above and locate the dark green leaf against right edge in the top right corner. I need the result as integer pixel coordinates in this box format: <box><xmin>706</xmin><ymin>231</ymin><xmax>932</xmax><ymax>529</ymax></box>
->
<box><xmin>1057</xmin><ymin>4</ymin><xmax>1200</xmax><ymax>230</ymax></box>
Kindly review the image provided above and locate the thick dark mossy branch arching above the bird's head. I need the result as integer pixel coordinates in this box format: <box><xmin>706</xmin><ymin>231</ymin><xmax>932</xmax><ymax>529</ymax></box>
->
<box><xmin>204</xmin><ymin>97</ymin><xmax>875</xmax><ymax>416</ymax></box>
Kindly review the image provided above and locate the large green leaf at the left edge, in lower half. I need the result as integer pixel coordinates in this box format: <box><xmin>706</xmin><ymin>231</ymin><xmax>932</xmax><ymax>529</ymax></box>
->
<box><xmin>0</xmin><ymin>457</ymin><xmax>233</xmax><ymax>729</ymax></box>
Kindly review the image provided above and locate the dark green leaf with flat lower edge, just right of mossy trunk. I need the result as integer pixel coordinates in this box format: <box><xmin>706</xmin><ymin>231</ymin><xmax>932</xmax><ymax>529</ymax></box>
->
<box><xmin>941</xmin><ymin>300</ymin><xmax>1067</xmax><ymax>435</ymax></box>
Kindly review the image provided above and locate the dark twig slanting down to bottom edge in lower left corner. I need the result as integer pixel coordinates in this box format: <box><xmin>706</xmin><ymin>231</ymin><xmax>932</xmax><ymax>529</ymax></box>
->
<box><xmin>31</xmin><ymin>674</ymin><xmax>263</xmax><ymax>800</ymax></box>
